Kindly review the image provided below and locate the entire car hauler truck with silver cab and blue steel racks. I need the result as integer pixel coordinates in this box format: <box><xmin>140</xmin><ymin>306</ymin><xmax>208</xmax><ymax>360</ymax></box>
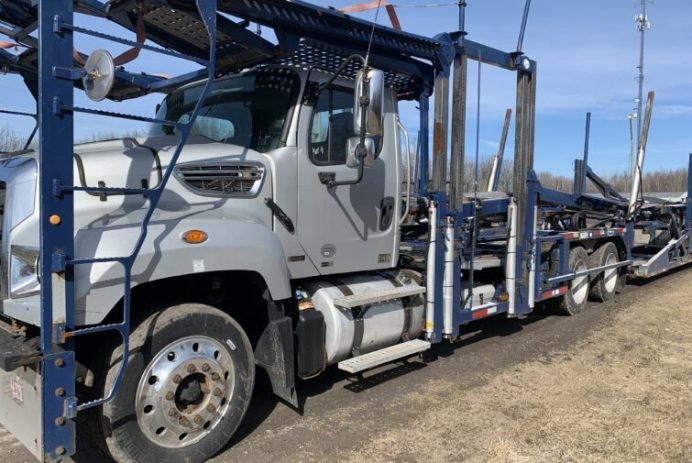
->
<box><xmin>0</xmin><ymin>0</ymin><xmax>692</xmax><ymax>461</ymax></box>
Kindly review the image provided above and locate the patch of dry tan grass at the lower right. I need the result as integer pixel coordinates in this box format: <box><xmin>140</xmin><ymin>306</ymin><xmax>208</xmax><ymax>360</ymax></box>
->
<box><xmin>340</xmin><ymin>274</ymin><xmax>692</xmax><ymax>463</ymax></box>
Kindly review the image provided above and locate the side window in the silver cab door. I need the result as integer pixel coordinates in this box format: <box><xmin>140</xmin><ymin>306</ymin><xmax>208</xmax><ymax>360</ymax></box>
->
<box><xmin>310</xmin><ymin>88</ymin><xmax>354</xmax><ymax>165</ymax></box>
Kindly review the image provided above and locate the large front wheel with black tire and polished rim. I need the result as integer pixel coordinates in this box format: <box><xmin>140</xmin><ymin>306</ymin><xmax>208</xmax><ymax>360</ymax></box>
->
<box><xmin>95</xmin><ymin>304</ymin><xmax>255</xmax><ymax>463</ymax></box>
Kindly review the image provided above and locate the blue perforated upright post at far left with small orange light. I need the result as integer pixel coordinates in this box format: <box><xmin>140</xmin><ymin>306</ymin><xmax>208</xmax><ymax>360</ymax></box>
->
<box><xmin>37</xmin><ymin>0</ymin><xmax>77</xmax><ymax>460</ymax></box>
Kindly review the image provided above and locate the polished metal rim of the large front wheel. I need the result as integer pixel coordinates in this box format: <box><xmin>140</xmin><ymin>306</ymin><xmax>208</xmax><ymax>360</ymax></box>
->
<box><xmin>135</xmin><ymin>336</ymin><xmax>235</xmax><ymax>448</ymax></box>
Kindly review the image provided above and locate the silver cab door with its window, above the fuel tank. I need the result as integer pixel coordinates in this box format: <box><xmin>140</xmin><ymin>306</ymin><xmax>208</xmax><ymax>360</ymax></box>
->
<box><xmin>297</xmin><ymin>83</ymin><xmax>401</xmax><ymax>274</ymax></box>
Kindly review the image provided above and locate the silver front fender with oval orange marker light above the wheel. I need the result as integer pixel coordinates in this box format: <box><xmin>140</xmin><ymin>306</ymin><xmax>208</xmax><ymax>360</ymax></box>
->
<box><xmin>75</xmin><ymin>209</ymin><xmax>291</xmax><ymax>325</ymax></box>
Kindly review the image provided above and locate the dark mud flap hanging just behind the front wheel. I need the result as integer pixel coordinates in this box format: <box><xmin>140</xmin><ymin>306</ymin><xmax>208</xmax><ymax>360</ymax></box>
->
<box><xmin>255</xmin><ymin>301</ymin><xmax>298</xmax><ymax>408</ymax></box>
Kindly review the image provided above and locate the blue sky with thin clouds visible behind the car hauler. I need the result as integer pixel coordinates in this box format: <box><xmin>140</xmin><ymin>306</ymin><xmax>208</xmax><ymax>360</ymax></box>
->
<box><xmin>0</xmin><ymin>0</ymin><xmax>692</xmax><ymax>175</ymax></box>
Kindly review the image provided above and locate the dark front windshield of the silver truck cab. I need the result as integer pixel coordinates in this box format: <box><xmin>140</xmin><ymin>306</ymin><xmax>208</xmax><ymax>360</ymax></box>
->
<box><xmin>151</xmin><ymin>69</ymin><xmax>300</xmax><ymax>153</ymax></box>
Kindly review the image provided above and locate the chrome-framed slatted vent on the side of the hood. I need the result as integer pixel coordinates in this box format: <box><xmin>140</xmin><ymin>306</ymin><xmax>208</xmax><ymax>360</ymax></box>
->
<box><xmin>176</xmin><ymin>163</ymin><xmax>264</xmax><ymax>196</ymax></box>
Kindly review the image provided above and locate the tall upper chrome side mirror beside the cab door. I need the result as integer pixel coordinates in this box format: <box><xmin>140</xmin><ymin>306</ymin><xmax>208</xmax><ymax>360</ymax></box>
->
<box><xmin>349</xmin><ymin>68</ymin><xmax>384</xmax><ymax>136</ymax></box>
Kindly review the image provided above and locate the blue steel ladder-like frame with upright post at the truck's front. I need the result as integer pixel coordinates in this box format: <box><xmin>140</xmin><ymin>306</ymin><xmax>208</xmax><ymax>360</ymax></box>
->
<box><xmin>37</xmin><ymin>0</ymin><xmax>217</xmax><ymax>460</ymax></box>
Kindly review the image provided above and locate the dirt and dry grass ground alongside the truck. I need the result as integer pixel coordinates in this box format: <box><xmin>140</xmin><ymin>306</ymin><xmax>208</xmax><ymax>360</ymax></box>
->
<box><xmin>0</xmin><ymin>268</ymin><xmax>692</xmax><ymax>463</ymax></box>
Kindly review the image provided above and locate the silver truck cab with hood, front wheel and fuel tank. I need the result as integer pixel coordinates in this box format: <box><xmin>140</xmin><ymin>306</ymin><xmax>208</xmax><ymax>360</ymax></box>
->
<box><xmin>0</xmin><ymin>62</ymin><xmax>428</xmax><ymax>459</ymax></box>
